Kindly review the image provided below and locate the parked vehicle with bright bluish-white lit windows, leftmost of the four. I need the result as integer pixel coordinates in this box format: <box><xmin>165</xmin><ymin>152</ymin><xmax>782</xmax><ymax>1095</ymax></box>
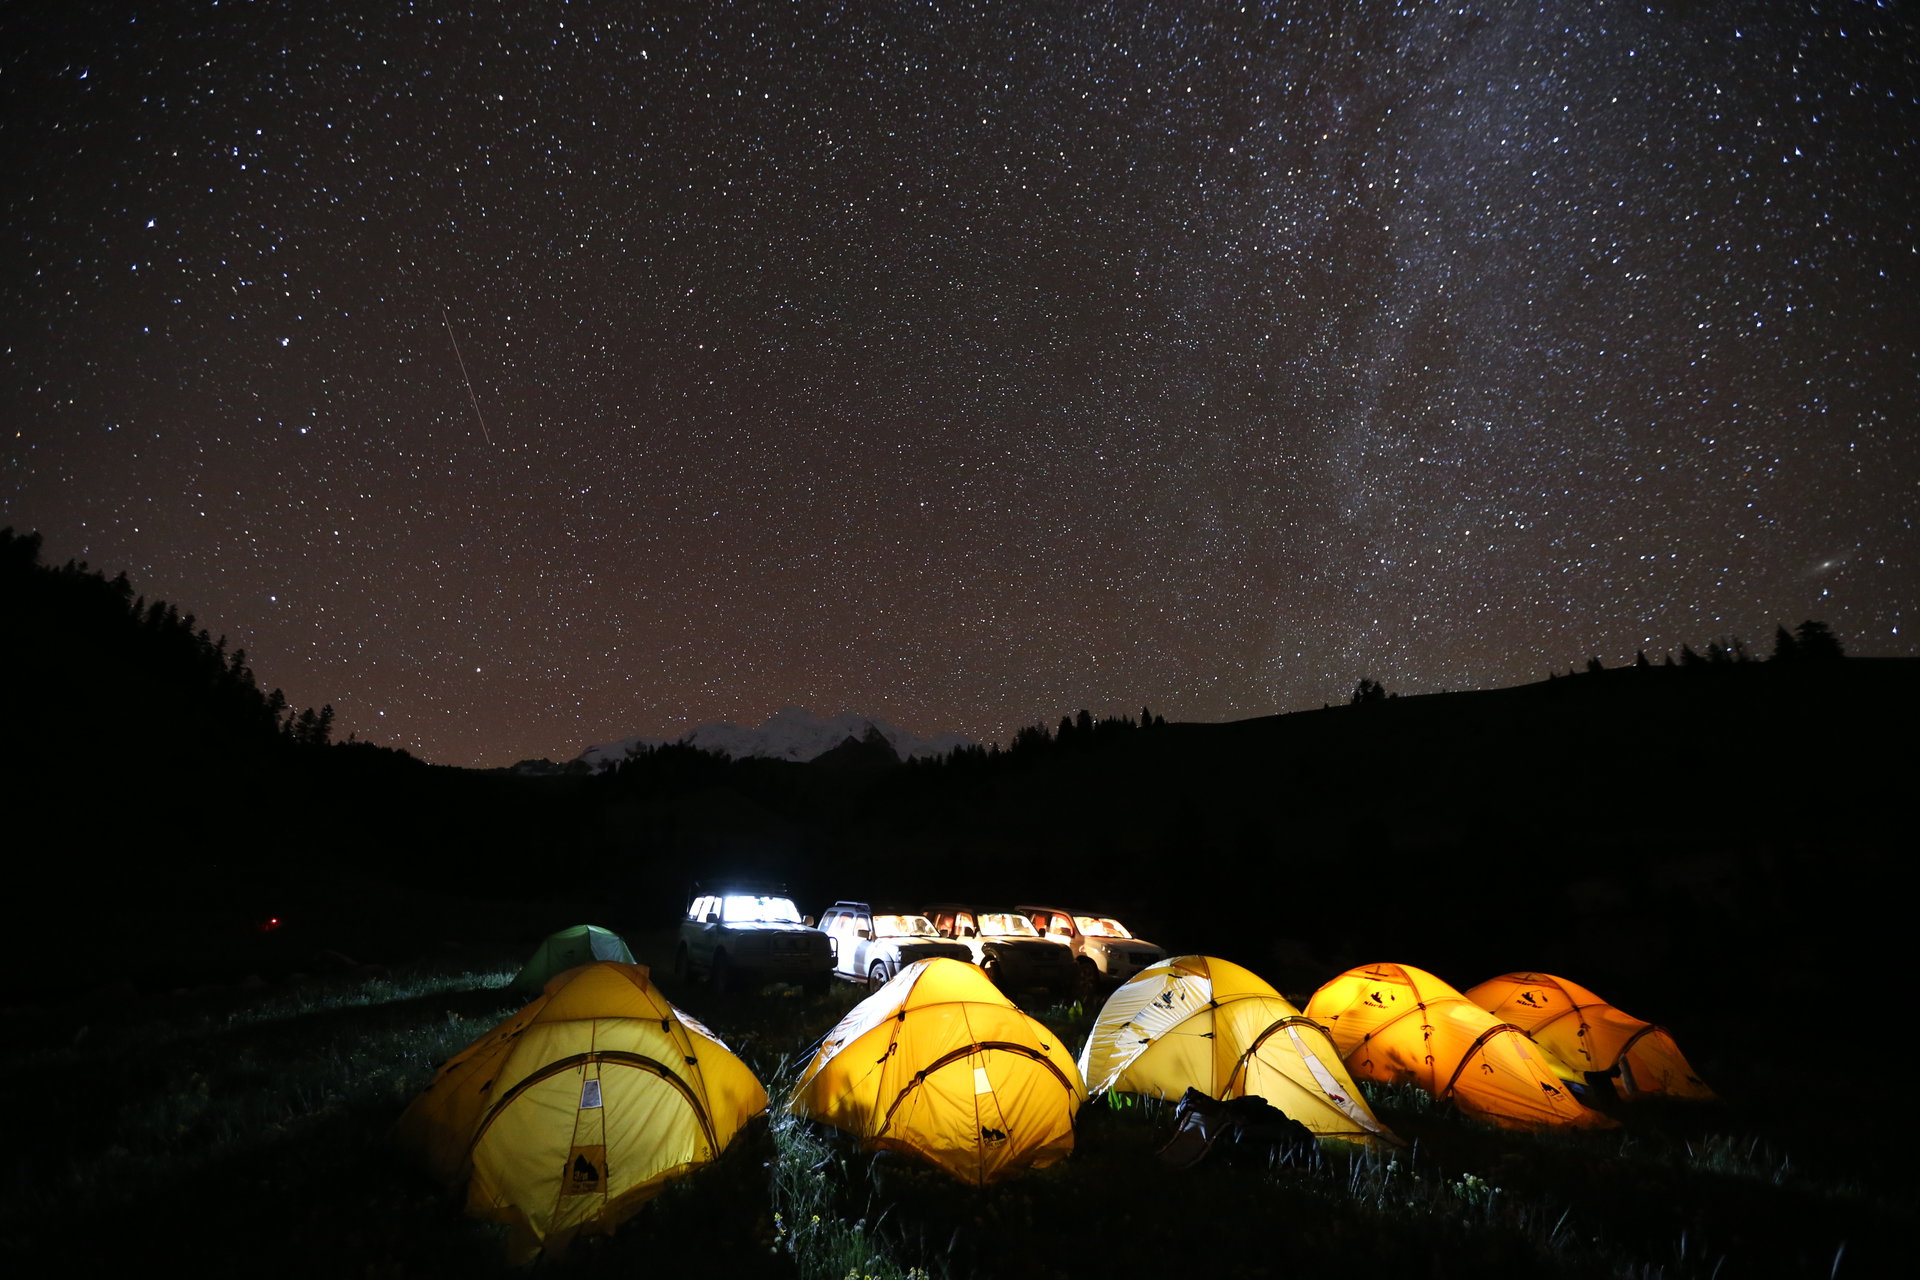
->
<box><xmin>674</xmin><ymin>887</ymin><xmax>833</xmax><ymax>990</ymax></box>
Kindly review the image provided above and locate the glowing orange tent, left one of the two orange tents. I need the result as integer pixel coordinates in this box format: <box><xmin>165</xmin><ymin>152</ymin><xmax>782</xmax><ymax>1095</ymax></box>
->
<box><xmin>1308</xmin><ymin>965</ymin><xmax>1613</xmax><ymax>1128</ymax></box>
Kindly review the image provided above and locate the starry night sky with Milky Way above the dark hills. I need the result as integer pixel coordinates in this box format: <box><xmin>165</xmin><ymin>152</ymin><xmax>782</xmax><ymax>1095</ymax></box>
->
<box><xmin>0</xmin><ymin>0</ymin><xmax>1920</xmax><ymax>766</ymax></box>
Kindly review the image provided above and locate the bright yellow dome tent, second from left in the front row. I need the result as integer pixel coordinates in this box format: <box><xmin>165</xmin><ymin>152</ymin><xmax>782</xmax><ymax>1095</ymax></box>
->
<box><xmin>787</xmin><ymin>958</ymin><xmax>1087</xmax><ymax>1186</ymax></box>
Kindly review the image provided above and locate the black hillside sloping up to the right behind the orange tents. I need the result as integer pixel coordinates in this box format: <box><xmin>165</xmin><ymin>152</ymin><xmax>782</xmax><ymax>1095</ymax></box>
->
<box><xmin>866</xmin><ymin>660</ymin><xmax>1920</xmax><ymax>1005</ymax></box>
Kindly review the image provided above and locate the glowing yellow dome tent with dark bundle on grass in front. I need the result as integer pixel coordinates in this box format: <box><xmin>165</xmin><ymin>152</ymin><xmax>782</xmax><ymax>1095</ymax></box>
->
<box><xmin>1079</xmin><ymin>956</ymin><xmax>1400</xmax><ymax>1144</ymax></box>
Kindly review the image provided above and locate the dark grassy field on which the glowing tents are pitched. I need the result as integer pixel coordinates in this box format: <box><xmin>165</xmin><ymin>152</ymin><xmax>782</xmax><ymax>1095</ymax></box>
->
<box><xmin>0</xmin><ymin>932</ymin><xmax>1916</xmax><ymax>1280</ymax></box>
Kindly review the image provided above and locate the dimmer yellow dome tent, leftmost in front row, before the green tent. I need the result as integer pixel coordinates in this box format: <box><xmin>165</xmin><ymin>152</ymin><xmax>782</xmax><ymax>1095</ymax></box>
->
<box><xmin>396</xmin><ymin>961</ymin><xmax>766</xmax><ymax>1261</ymax></box>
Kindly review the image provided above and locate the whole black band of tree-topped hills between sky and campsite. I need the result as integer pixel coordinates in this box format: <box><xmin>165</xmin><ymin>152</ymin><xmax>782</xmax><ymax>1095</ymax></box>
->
<box><xmin>0</xmin><ymin>533</ymin><xmax>1920</xmax><ymax>1011</ymax></box>
